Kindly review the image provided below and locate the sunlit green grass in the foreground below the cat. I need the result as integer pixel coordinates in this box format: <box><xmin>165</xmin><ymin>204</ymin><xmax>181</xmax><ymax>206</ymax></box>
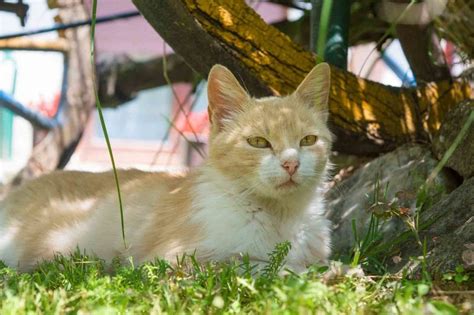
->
<box><xmin>0</xmin><ymin>251</ymin><xmax>466</xmax><ymax>314</ymax></box>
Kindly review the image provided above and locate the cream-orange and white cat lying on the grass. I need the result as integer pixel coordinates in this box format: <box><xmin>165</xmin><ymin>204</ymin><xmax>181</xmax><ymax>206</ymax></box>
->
<box><xmin>0</xmin><ymin>63</ymin><xmax>332</xmax><ymax>271</ymax></box>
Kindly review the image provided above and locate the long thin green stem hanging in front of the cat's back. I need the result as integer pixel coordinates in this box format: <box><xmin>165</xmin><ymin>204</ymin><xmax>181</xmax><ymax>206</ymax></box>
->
<box><xmin>90</xmin><ymin>0</ymin><xmax>127</xmax><ymax>248</ymax></box>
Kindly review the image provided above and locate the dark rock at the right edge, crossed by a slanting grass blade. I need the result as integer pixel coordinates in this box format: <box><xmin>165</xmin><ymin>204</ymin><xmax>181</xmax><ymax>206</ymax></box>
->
<box><xmin>433</xmin><ymin>100</ymin><xmax>474</xmax><ymax>179</ymax></box>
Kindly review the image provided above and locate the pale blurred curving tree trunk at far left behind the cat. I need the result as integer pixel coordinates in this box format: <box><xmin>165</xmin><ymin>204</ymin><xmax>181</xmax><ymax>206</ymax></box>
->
<box><xmin>13</xmin><ymin>0</ymin><xmax>95</xmax><ymax>184</ymax></box>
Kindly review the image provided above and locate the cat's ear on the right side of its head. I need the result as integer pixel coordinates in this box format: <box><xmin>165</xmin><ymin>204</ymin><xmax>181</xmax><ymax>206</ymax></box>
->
<box><xmin>295</xmin><ymin>62</ymin><xmax>331</xmax><ymax>119</ymax></box>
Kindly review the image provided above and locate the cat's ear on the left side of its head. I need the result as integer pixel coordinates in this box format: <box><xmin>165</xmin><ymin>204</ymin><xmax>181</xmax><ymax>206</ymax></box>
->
<box><xmin>207</xmin><ymin>65</ymin><xmax>250</xmax><ymax>125</ymax></box>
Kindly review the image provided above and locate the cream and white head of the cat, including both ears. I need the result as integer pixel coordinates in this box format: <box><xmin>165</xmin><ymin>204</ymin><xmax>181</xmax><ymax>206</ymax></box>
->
<box><xmin>208</xmin><ymin>63</ymin><xmax>332</xmax><ymax>198</ymax></box>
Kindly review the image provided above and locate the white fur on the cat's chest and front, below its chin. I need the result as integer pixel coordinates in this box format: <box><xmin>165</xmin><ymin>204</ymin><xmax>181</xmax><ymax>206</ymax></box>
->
<box><xmin>192</xmin><ymin>168</ymin><xmax>330</xmax><ymax>271</ymax></box>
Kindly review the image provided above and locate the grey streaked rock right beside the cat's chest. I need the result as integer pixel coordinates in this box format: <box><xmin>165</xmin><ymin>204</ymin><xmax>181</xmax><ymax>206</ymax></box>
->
<box><xmin>326</xmin><ymin>145</ymin><xmax>457</xmax><ymax>258</ymax></box>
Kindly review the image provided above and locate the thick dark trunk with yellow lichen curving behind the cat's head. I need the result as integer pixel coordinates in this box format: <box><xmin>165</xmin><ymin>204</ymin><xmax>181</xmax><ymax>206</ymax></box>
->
<box><xmin>133</xmin><ymin>0</ymin><xmax>470</xmax><ymax>154</ymax></box>
